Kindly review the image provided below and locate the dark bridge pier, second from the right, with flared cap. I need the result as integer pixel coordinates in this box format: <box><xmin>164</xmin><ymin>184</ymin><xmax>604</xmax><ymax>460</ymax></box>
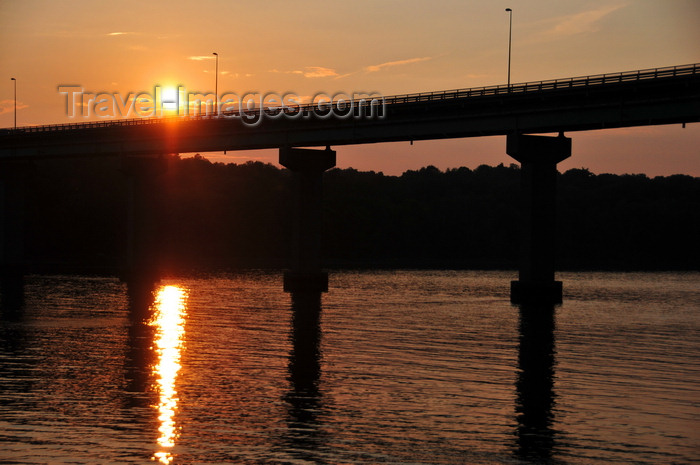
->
<box><xmin>280</xmin><ymin>147</ymin><xmax>335</xmax><ymax>292</ymax></box>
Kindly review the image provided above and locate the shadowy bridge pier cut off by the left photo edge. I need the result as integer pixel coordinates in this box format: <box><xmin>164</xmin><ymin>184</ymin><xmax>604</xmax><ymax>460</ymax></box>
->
<box><xmin>0</xmin><ymin>160</ymin><xmax>35</xmax><ymax>306</ymax></box>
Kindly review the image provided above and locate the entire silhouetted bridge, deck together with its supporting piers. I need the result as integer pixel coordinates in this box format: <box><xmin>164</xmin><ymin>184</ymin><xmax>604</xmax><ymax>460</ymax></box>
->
<box><xmin>0</xmin><ymin>64</ymin><xmax>700</xmax><ymax>303</ymax></box>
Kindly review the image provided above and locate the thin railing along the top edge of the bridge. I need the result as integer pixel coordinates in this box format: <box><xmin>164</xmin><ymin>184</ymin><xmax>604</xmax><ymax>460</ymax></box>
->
<box><xmin>0</xmin><ymin>63</ymin><xmax>700</xmax><ymax>135</ymax></box>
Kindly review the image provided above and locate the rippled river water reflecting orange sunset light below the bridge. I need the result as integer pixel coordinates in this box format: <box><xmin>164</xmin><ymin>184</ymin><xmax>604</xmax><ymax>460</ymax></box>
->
<box><xmin>0</xmin><ymin>271</ymin><xmax>700</xmax><ymax>464</ymax></box>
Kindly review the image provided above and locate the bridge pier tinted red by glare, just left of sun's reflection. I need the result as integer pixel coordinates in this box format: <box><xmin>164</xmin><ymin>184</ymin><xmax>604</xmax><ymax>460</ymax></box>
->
<box><xmin>121</xmin><ymin>157</ymin><xmax>167</xmax><ymax>282</ymax></box>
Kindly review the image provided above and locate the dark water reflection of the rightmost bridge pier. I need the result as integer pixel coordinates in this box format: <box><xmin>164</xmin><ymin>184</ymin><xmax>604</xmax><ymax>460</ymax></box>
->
<box><xmin>516</xmin><ymin>304</ymin><xmax>555</xmax><ymax>463</ymax></box>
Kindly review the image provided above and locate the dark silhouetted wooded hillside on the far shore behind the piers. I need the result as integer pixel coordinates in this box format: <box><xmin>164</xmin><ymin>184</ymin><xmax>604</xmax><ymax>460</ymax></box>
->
<box><xmin>25</xmin><ymin>156</ymin><xmax>700</xmax><ymax>273</ymax></box>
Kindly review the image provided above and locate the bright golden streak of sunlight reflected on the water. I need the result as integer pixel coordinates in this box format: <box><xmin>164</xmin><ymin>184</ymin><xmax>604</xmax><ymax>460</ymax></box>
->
<box><xmin>149</xmin><ymin>286</ymin><xmax>187</xmax><ymax>464</ymax></box>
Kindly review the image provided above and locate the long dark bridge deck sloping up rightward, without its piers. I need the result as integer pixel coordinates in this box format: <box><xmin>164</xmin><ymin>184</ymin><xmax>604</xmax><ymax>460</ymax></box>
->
<box><xmin>0</xmin><ymin>64</ymin><xmax>700</xmax><ymax>158</ymax></box>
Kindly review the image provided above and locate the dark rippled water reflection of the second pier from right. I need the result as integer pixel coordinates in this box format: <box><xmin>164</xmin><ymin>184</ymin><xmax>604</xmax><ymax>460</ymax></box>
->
<box><xmin>284</xmin><ymin>292</ymin><xmax>323</xmax><ymax>463</ymax></box>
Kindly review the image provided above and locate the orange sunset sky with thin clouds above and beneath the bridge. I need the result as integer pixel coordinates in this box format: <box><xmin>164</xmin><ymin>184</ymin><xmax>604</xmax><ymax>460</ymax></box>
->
<box><xmin>0</xmin><ymin>0</ymin><xmax>700</xmax><ymax>176</ymax></box>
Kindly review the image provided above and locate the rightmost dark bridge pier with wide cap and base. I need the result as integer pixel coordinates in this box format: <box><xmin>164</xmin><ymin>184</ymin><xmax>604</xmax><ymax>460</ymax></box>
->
<box><xmin>506</xmin><ymin>134</ymin><xmax>571</xmax><ymax>304</ymax></box>
